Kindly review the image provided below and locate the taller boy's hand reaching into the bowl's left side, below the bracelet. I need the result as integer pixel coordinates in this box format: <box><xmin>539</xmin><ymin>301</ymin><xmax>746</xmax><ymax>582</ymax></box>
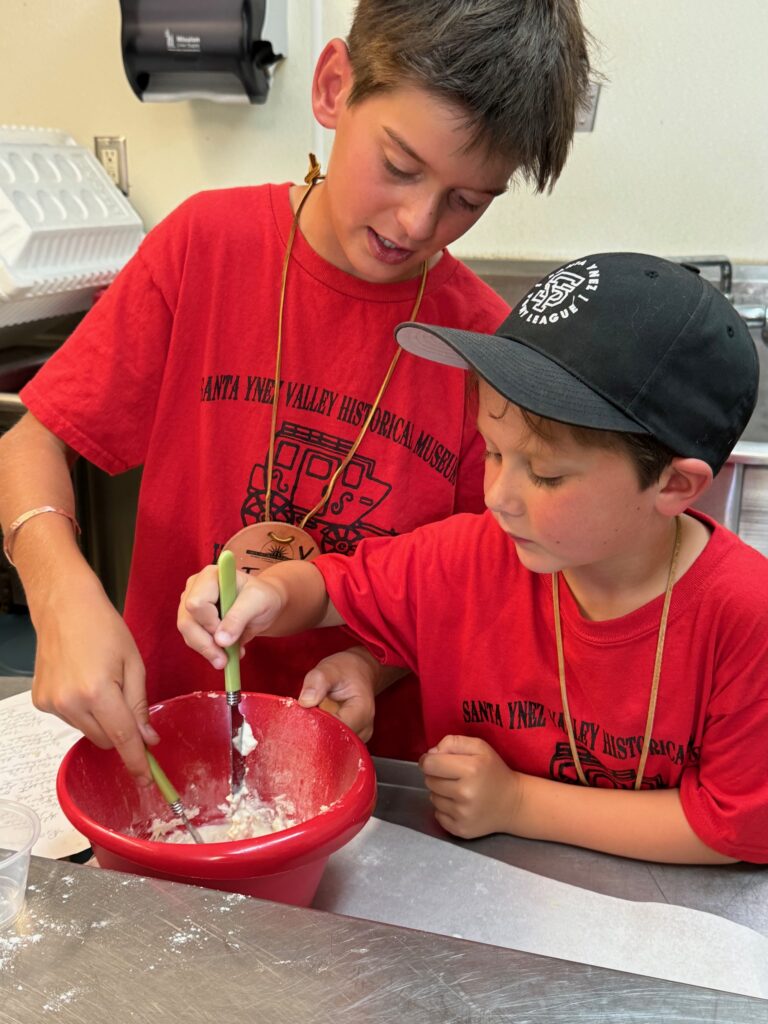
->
<box><xmin>32</xmin><ymin>580</ymin><xmax>159</xmax><ymax>785</ymax></box>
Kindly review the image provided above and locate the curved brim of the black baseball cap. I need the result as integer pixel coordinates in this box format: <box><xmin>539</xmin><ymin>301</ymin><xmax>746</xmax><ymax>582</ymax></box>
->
<box><xmin>395</xmin><ymin>323</ymin><xmax>648</xmax><ymax>433</ymax></box>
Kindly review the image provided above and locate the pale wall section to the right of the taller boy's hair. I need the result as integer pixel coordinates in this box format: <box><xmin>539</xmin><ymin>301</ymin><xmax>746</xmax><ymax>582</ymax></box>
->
<box><xmin>462</xmin><ymin>0</ymin><xmax>768</xmax><ymax>263</ymax></box>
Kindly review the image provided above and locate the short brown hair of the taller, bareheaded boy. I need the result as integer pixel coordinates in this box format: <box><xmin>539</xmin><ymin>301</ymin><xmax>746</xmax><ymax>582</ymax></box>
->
<box><xmin>347</xmin><ymin>0</ymin><xmax>590</xmax><ymax>191</ymax></box>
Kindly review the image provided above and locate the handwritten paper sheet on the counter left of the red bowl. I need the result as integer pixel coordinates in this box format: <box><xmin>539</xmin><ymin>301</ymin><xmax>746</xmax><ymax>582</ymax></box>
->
<box><xmin>0</xmin><ymin>692</ymin><xmax>89</xmax><ymax>858</ymax></box>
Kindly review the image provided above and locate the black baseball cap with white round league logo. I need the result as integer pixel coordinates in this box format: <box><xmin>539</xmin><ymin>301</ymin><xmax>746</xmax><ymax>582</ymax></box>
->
<box><xmin>395</xmin><ymin>253</ymin><xmax>759</xmax><ymax>473</ymax></box>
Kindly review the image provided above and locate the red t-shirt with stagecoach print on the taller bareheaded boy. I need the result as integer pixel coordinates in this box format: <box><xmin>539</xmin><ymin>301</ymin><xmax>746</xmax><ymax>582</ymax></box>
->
<box><xmin>22</xmin><ymin>184</ymin><xmax>508</xmax><ymax>758</ymax></box>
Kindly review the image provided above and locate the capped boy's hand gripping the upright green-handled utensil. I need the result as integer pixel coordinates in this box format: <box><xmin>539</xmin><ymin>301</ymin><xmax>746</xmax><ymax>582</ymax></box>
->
<box><xmin>176</xmin><ymin>565</ymin><xmax>284</xmax><ymax>669</ymax></box>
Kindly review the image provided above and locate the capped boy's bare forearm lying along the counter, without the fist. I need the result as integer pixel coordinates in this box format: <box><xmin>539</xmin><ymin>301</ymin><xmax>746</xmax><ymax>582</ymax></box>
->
<box><xmin>507</xmin><ymin>775</ymin><xmax>733</xmax><ymax>864</ymax></box>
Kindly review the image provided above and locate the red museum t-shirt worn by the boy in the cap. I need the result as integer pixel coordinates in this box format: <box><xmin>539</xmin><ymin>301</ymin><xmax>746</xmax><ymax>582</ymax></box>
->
<box><xmin>316</xmin><ymin>513</ymin><xmax>768</xmax><ymax>862</ymax></box>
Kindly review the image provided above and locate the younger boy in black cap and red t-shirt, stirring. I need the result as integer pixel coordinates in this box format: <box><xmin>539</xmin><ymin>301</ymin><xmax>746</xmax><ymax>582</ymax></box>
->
<box><xmin>181</xmin><ymin>253</ymin><xmax>768</xmax><ymax>863</ymax></box>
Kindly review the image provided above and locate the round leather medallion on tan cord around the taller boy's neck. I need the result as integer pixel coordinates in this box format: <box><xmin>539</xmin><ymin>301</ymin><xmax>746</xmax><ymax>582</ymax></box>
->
<box><xmin>224</xmin><ymin>154</ymin><xmax>428</xmax><ymax>574</ymax></box>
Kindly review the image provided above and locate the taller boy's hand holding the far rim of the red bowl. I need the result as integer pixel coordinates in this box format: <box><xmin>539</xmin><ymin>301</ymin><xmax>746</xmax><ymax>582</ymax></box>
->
<box><xmin>299</xmin><ymin>648</ymin><xmax>377</xmax><ymax>743</ymax></box>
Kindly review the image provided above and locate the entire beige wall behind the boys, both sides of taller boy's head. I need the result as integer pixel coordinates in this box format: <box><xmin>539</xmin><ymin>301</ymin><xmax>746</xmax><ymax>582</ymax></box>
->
<box><xmin>0</xmin><ymin>0</ymin><xmax>768</xmax><ymax>263</ymax></box>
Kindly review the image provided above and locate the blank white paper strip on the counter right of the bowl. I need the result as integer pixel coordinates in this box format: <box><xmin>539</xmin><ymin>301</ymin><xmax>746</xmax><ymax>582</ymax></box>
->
<box><xmin>312</xmin><ymin>818</ymin><xmax>768</xmax><ymax>999</ymax></box>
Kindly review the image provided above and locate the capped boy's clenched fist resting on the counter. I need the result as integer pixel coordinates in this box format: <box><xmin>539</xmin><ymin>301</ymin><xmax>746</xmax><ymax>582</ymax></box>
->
<box><xmin>419</xmin><ymin>736</ymin><xmax>521</xmax><ymax>839</ymax></box>
